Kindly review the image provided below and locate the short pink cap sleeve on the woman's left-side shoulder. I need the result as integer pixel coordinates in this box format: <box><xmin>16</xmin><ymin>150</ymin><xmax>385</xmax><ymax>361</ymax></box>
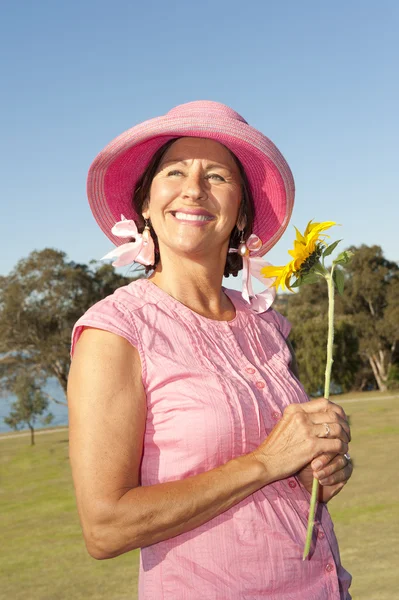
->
<box><xmin>71</xmin><ymin>296</ymin><xmax>139</xmax><ymax>357</ymax></box>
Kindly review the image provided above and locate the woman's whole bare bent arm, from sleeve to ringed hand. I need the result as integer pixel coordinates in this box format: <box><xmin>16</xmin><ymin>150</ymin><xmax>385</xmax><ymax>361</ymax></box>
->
<box><xmin>68</xmin><ymin>329</ymin><xmax>347</xmax><ymax>559</ymax></box>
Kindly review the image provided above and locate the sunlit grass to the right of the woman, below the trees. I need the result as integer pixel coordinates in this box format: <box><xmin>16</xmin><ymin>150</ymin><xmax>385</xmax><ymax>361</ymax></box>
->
<box><xmin>329</xmin><ymin>392</ymin><xmax>399</xmax><ymax>600</ymax></box>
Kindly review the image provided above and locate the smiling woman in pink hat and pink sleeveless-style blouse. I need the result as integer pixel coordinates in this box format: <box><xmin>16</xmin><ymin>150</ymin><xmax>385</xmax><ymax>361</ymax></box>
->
<box><xmin>69</xmin><ymin>102</ymin><xmax>352</xmax><ymax>600</ymax></box>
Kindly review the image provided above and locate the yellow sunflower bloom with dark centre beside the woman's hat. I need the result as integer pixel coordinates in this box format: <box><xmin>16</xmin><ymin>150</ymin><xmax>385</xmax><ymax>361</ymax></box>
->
<box><xmin>261</xmin><ymin>221</ymin><xmax>336</xmax><ymax>291</ymax></box>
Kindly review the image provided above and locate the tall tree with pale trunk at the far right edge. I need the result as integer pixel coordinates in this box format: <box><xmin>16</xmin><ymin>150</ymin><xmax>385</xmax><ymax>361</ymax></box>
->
<box><xmin>337</xmin><ymin>245</ymin><xmax>399</xmax><ymax>391</ymax></box>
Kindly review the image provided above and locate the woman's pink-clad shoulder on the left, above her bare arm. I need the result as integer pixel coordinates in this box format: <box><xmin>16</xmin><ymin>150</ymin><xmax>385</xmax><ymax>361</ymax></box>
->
<box><xmin>71</xmin><ymin>279</ymin><xmax>151</xmax><ymax>355</ymax></box>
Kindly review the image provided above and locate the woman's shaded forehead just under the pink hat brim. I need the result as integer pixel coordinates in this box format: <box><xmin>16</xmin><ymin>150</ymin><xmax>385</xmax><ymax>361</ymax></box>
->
<box><xmin>162</xmin><ymin>137</ymin><xmax>237</xmax><ymax>169</ymax></box>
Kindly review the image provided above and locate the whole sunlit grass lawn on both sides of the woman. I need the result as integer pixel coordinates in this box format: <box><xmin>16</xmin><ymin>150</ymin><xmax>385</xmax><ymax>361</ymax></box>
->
<box><xmin>0</xmin><ymin>392</ymin><xmax>399</xmax><ymax>600</ymax></box>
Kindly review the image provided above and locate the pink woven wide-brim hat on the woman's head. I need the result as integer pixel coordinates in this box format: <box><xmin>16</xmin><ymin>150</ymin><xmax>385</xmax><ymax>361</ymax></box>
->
<box><xmin>87</xmin><ymin>101</ymin><xmax>295</xmax><ymax>256</ymax></box>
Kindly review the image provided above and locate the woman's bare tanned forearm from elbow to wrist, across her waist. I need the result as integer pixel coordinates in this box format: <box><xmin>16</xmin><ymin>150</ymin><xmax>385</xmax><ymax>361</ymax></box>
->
<box><xmin>85</xmin><ymin>454</ymin><xmax>272</xmax><ymax>559</ymax></box>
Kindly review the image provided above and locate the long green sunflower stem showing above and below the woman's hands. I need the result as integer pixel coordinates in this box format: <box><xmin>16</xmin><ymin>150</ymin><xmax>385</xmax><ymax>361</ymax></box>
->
<box><xmin>302</xmin><ymin>265</ymin><xmax>334</xmax><ymax>560</ymax></box>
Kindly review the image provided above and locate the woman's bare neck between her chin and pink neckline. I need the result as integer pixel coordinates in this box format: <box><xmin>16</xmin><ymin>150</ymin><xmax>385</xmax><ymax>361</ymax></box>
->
<box><xmin>149</xmin><ymin>246</ymin><xmax>235</xmax><ymax>321</ymax></box>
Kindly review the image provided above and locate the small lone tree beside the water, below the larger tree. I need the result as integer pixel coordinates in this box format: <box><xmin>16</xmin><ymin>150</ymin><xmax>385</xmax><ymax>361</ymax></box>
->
<box><xmin>4</xmin><ymin>373</ymin><xmax>53</xmax><ymax>446</ymax></box>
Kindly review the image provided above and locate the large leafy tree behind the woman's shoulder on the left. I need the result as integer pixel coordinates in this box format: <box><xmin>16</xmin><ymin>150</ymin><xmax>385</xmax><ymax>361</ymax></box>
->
<box><xmin>0</xmin><ymin>248</ymin><xmax>137</xmax><ymax>404</ymax></box>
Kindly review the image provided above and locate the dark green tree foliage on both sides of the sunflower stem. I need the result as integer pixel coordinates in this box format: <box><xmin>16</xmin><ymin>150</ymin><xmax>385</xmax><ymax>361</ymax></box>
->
<box><xmin>286</xmin><ymin>245</ymin><xmax>399</xmax><ymax>393</ymax></box>
